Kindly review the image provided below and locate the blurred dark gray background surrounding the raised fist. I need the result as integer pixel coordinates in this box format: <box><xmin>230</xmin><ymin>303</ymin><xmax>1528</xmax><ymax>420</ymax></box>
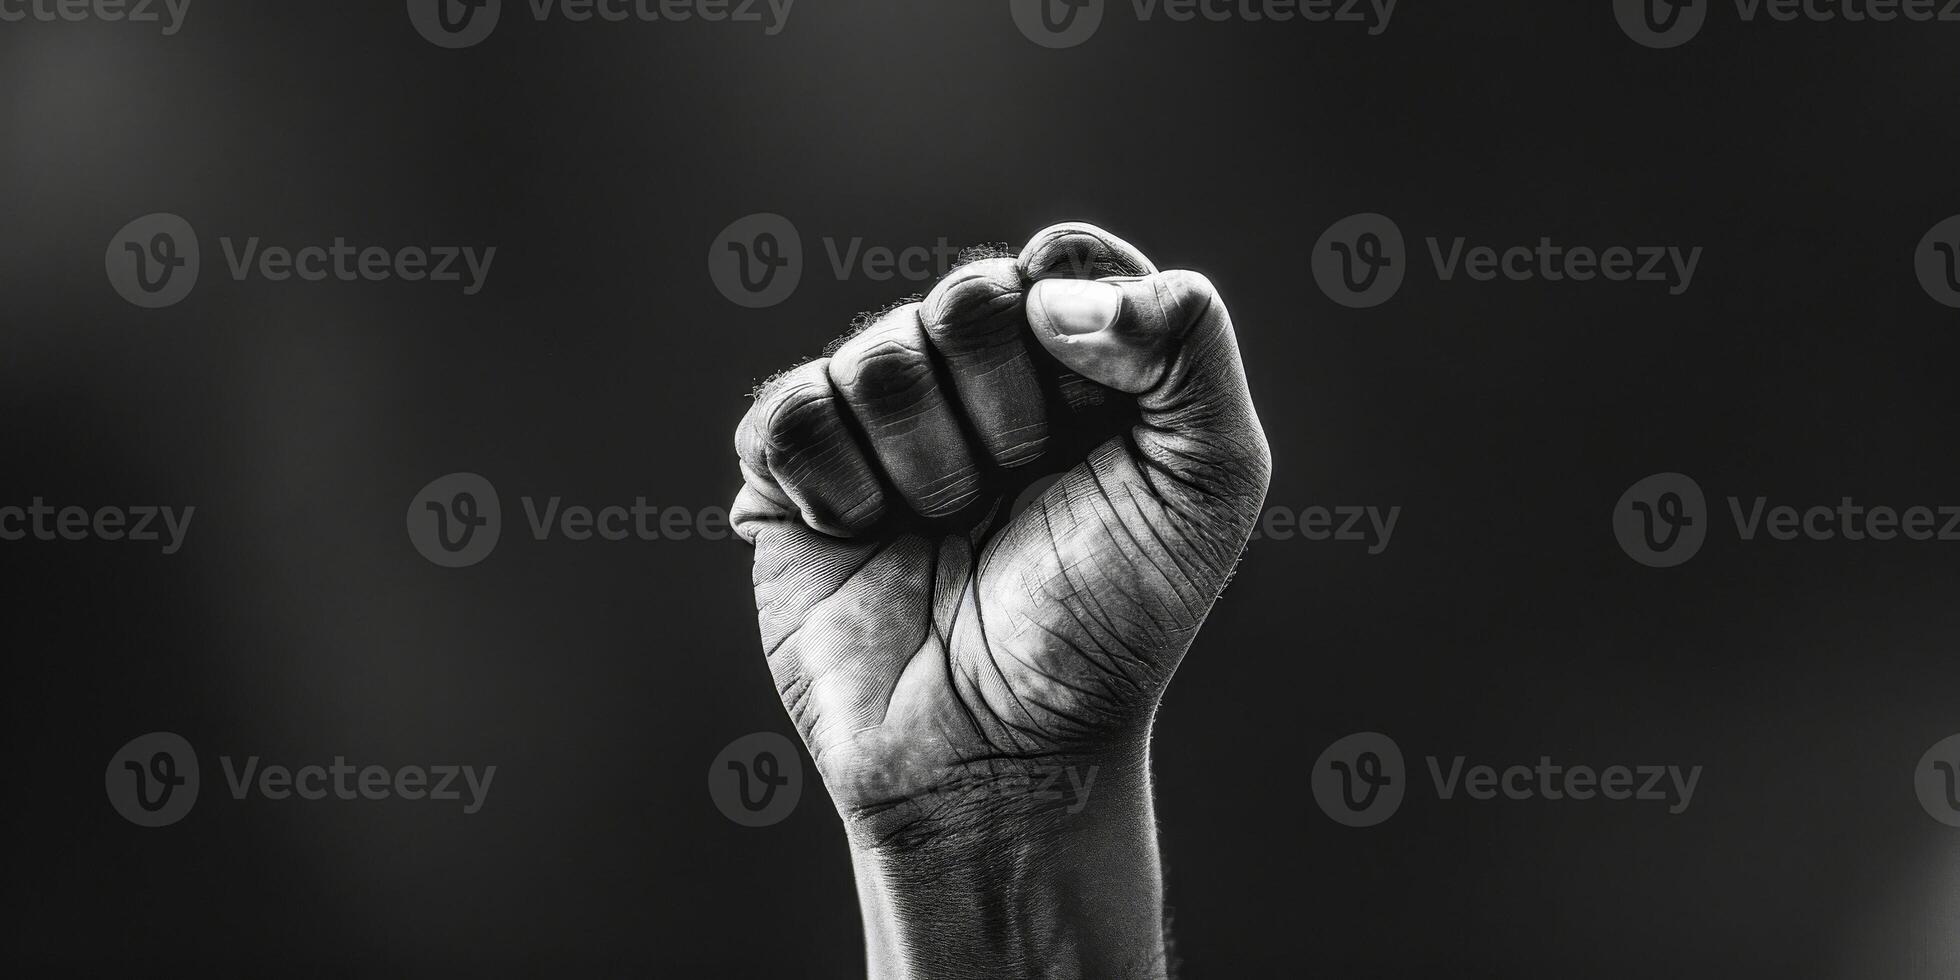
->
<box><xmin>0</xmin><ymin>0</ymin><xmax>1960</xmax><ymax>978</ymax></box>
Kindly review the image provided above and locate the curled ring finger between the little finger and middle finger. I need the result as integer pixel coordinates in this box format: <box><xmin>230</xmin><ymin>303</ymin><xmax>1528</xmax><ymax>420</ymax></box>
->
<box><xmin>829</xmin><ymin>304</ymin><xmax>980</xmax><ymax>517</ymax></box>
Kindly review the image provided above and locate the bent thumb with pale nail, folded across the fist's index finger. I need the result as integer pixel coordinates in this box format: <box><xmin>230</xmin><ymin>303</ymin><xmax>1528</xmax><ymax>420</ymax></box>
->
<box><xmin>1027</xmin><ymin>270</ymin><xmax>1272</xmax><ymax>510</ymax></box>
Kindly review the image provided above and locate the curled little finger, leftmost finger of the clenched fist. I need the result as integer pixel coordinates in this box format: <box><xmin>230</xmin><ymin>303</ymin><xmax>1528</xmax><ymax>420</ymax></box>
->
<box><xmin>735</xmin><ymin>361</ymin><xmax>886</xmax><ymax>537</ymax></box>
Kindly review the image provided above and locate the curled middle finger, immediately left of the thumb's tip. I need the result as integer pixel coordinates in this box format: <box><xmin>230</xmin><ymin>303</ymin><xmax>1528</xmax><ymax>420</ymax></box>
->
<box><xmin>919</xmin><ymin>259</ymin><xmax>1049</xmax><ymax>468</ymax></box>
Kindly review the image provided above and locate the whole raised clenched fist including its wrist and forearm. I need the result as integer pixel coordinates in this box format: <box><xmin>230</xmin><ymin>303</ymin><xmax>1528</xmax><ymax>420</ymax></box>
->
<box><xmin>733</xmin><ymin>223</ymin><xmax>1270</xmax><ymax>978</ymax></box>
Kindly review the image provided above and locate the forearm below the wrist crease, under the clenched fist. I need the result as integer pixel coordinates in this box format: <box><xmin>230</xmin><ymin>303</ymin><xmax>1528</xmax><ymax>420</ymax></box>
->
<box><xmin>851</xmin><ymin>759</ymin><xmax>1164</xmax><ymax>980</ymax></box>
